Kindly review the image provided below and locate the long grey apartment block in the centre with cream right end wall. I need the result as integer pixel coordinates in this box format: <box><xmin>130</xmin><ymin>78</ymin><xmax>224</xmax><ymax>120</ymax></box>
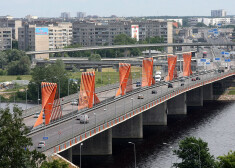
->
<box><xmin>73</xmin><ymin>20</ymin><xmax>173</xmax><ymax>46</ymax></box>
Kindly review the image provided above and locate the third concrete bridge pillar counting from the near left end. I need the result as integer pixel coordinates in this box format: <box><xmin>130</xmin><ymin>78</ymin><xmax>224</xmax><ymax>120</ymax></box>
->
<box><xmin>143</xmin><ymin>102</ymin><xmax>167</xmax><ymax>125</ymax></box>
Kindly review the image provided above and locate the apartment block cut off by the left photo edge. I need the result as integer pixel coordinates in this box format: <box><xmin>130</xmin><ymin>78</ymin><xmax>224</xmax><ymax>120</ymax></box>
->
<box><xmin>0</xmin><ymin>27</ymin><xmax>12</xmax><ymax>51</ymax></box>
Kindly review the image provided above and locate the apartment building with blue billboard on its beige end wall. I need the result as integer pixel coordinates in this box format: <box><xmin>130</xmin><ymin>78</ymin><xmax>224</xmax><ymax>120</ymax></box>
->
<box><xmin>18</xmin><ymin>25</ymin><xmax>49</xmax><ymax>59</ymax></box>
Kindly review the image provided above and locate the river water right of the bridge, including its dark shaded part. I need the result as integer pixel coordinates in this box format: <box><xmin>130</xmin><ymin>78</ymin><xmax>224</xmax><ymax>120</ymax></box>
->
<box><xmin>73</xmin><ymin>102</ymin><xmax>235</xmax><ymax>168</ymax></box>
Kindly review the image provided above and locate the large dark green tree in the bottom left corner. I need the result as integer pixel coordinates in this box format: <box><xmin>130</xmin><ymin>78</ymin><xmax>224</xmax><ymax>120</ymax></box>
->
<box><xmin>0</xmin><ymin>106</ymin><xmax>45</xmax><ymax>168</ymax></box>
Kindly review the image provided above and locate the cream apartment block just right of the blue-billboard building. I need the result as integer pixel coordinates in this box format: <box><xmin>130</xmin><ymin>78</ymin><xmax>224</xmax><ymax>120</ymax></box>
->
<box><xmin>48</xmin><ymin>22</ymin><xmax>73</xmax><ymax>50</ymax></box>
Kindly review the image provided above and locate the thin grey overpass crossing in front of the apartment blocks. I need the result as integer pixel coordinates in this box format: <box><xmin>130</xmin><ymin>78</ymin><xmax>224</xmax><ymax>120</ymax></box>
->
<box><xmin>26</xmin><ymin>43</ymin><xmax>235</xmax><ymax>55</ymax></box>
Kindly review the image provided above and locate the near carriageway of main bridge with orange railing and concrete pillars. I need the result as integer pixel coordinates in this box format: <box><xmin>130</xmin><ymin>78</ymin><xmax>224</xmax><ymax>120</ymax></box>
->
<box><xmin>24</xmin><ymin>70</ymin><xmax>235</xmax><ymax>160</ymax></box>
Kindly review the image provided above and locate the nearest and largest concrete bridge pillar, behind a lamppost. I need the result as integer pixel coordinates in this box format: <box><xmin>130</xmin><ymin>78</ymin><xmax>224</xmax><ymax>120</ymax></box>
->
<box><xmin>73</xmin><ymin>129</ymin><xmax>112</xmax><ymax>155</ymax></box>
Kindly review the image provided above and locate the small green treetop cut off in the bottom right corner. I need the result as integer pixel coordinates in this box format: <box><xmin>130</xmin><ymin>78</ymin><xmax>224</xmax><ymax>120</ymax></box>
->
<box><xmin>218</xmin><ymin>151</ymin><xmax>235</xmax><ymax>168</ymax></box>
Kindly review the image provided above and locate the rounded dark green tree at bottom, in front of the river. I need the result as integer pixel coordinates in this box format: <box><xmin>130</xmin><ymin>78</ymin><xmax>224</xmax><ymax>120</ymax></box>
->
<box><xmin>173</xmin><ymin>137</ymin><xmax>216</xmax><ymax>168</ymax></box>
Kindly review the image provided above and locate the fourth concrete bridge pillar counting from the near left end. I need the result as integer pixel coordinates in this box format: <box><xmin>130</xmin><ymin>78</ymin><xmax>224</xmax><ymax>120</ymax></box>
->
<box><xmin>167</xmin><ymin>93</ymin><xmax>187</xmax><ymax>115</ymax></box>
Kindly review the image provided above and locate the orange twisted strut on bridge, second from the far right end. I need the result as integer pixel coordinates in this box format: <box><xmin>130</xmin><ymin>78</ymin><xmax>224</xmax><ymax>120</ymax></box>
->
<box><xmin>166</xmin><ymin>55</ymin><xmax>177</xmax><ymax>81</ymax></box>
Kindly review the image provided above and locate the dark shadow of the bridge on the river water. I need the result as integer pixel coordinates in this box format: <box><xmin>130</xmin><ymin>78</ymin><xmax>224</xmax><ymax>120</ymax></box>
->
<box><xmin>73</xmin><ymin>101</ymin><xmax>234</xmax><ymax>168</ymax></box>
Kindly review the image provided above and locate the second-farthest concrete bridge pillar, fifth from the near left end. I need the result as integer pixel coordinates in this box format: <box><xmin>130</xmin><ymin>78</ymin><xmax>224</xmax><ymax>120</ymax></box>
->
<box><xmin>186</xmin><ymin>87</ymin><xmax>203</xmax><ymax>106</ymax></box>
